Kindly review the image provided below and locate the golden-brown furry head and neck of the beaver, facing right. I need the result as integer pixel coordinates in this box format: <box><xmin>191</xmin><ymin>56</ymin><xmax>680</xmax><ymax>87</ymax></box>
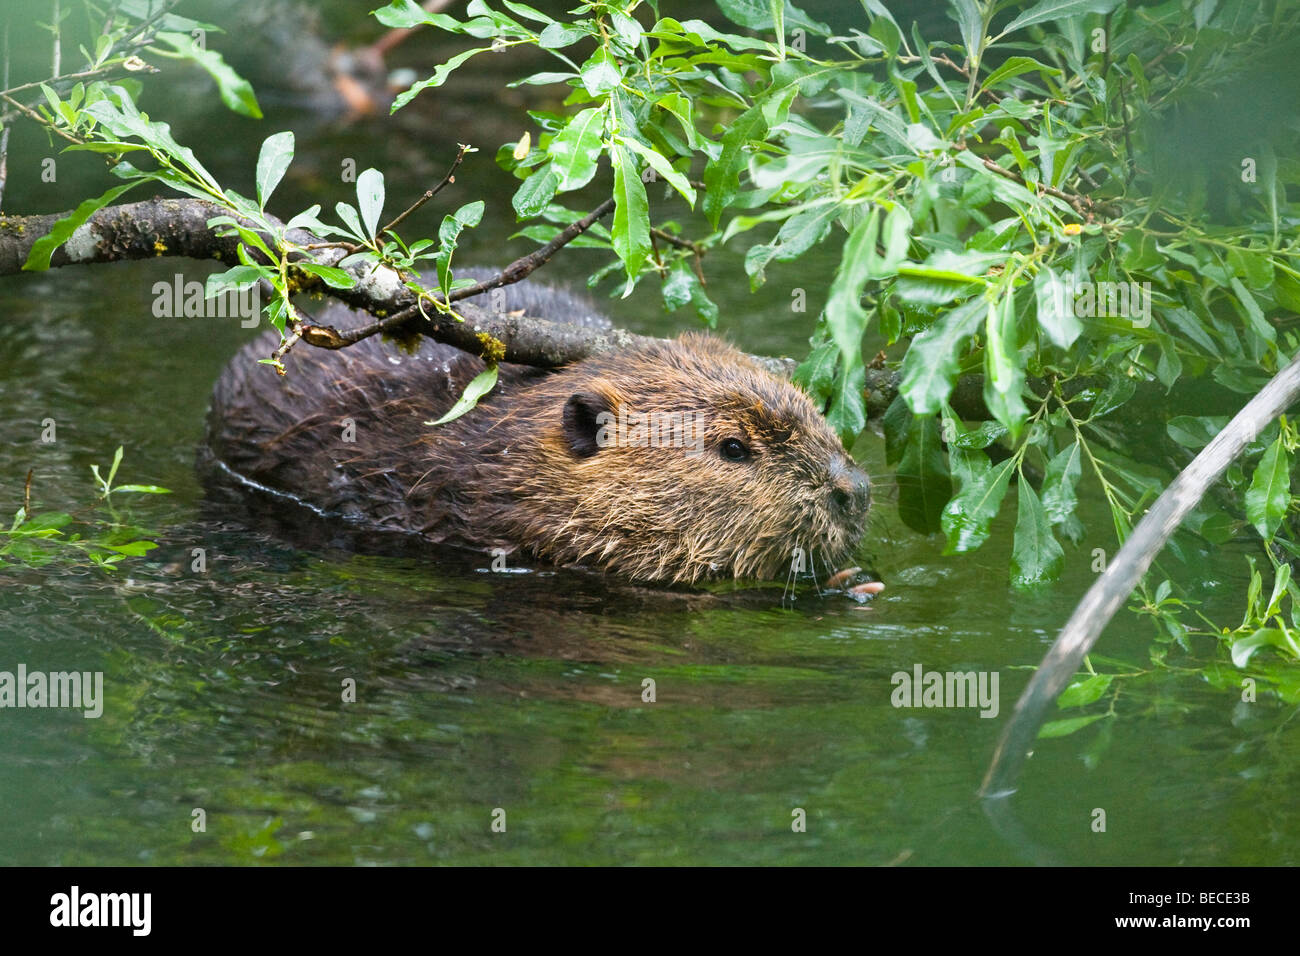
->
<box><xmin>462</xmin><ymin>334</ymin><xmax>870</xmax><ymax>583</ymax></box>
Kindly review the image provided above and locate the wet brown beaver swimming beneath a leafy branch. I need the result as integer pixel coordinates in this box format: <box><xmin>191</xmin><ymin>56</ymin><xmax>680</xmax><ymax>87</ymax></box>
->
<box><xmin>207</xmin><ymin>271</ymin><xmax>870</xmax><ymax>584</ymax></box>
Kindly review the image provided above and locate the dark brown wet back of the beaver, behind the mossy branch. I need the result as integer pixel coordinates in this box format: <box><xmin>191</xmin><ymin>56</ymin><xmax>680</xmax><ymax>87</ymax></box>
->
<box><xmin>203</xmin><ymin>269</ymin><xmax>610</xmax><ymax>537</ymax></box>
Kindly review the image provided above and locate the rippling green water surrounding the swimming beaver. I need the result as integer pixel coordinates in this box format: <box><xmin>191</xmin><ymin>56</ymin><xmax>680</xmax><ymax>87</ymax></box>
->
<box><xmin>0</xmin><ymin>1</ymin><xmax>1300</xmax><ymax>865</ymax></box>
